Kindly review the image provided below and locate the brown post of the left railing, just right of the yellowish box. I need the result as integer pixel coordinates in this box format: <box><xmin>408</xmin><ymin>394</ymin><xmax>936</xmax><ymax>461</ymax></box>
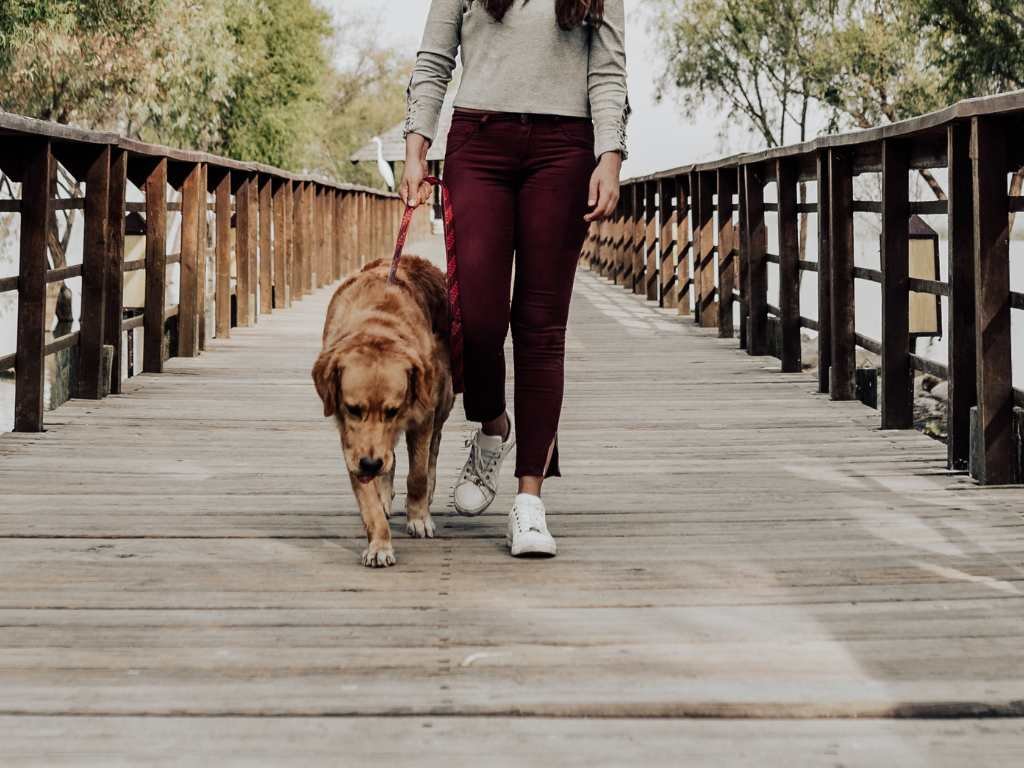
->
<box><xmin>142</xmin><ymin>158</ymin><xmax>167</xmax><ymax>374</ymax></box>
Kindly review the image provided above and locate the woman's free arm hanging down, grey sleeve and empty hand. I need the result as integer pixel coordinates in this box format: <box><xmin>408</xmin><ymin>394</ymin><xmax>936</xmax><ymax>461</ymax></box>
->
<box><xmin>586</xmin><ymin>0</ymin><xmax>630</xmax><ymax>221</ymax></box>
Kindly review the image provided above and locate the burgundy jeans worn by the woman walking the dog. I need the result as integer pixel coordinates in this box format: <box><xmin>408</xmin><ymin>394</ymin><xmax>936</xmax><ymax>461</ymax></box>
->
<box><xmin>444</xmin><ymin>111</ymin><xmax>595</xmax><ymax>477</ymax></box>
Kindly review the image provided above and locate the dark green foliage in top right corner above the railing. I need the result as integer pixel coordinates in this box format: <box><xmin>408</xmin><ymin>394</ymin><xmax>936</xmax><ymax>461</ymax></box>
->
<box><xmin>913</xmin><ymin>0</ymin><xmax>1024</xmax><ymax>99</ymax></box>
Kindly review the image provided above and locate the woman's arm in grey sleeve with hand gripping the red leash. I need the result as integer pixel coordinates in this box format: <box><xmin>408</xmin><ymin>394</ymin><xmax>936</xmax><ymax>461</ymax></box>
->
<box><xmin>398</xmin><ymin>0</ymin><xmax>463</xmax><ymax>205</ymax></box>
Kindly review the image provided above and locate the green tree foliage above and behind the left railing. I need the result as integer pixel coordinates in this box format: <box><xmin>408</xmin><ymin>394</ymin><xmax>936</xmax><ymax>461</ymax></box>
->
<box><xmin>0</xmin><ymin>0</ymin><xmax>410</xmax><ymax>184</ymax></box>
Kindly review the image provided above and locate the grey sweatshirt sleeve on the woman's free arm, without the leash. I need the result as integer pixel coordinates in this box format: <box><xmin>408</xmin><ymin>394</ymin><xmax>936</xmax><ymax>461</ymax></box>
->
<box><xmin>587</xmin><ymin>0</ymin><xmax>630</xmax><ymax>160</ymax></box>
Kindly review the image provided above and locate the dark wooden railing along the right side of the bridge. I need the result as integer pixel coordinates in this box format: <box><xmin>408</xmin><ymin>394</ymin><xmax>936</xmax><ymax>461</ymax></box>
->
<box><xmin>584</xmin><ymin>92</ymin><xmax>1024</xmax><ymax>483</ymax></box>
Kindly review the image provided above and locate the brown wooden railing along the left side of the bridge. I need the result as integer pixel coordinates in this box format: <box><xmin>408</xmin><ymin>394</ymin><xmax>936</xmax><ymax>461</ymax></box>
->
<box><xmin>0</xmin><ymin>113</ymin><xmax>422</xmax><ymax>432</ymax></box>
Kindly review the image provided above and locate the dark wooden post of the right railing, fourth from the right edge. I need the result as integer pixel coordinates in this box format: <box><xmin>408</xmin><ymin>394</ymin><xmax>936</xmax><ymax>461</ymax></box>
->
<box><xmin>828</xmin><ymin>150</ymin><xmax>857</xmax><ymax>400</ymax></box>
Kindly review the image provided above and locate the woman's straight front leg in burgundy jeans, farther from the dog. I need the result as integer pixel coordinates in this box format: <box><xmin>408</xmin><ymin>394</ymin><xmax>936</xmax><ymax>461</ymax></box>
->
<box><xmin>511</xmin><ymin>122</ymin><xmax>595</xmax><ymax>496</ymax></box>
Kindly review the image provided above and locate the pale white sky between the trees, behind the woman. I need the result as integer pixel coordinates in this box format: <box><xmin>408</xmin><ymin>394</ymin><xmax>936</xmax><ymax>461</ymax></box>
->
<box><xmin>322</xmin><ymin>0</ymin><xmax>737</xmax><ymax>177</ymax></box>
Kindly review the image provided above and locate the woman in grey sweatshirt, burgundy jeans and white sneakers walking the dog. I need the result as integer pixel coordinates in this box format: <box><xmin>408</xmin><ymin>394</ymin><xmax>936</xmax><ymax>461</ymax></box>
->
<box><xmin>400</xmin><ymin>0</ymin><xmax>629</xmax><ymax>556</ymax></box>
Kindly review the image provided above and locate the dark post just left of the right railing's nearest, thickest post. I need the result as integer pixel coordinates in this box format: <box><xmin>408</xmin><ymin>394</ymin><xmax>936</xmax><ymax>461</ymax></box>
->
<box><xmin>946</xmin><ymin>122</ymin><xmax>978</xmax><ymax>470</ymax></box>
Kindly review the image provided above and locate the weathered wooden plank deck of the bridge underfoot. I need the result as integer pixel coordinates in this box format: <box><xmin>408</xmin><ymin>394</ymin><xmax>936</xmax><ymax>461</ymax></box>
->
<box><xmin>0</xmin><ymin>239</ymin><xmax>1024</xmax><ymax>766</ymax></box>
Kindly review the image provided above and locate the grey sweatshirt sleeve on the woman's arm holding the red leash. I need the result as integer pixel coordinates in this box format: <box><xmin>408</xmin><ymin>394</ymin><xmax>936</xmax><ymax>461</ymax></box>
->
<box><xmin>404</xmin><ymin>0</ymin><xmax>463</xmax><ymax>142</ymax></box>
